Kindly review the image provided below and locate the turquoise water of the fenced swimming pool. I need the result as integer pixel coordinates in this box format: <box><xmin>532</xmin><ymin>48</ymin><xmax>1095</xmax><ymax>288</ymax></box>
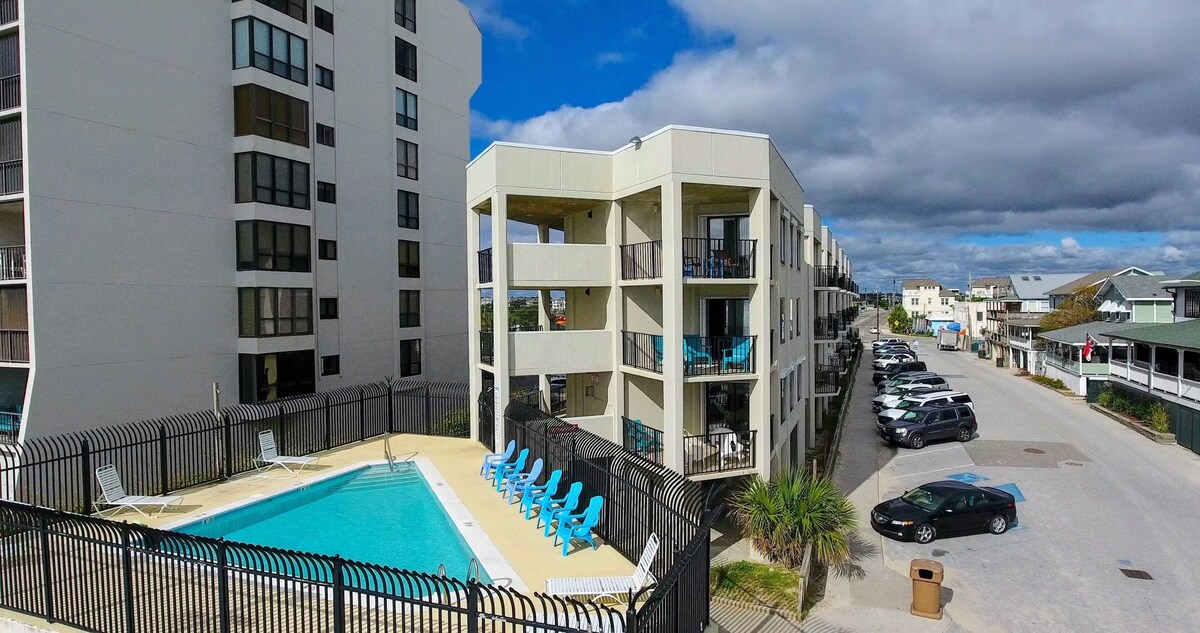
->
<box><xmin>175</xmin><ymin>463</ymin><xmax>491</xmax><ymax>583</ymax></box>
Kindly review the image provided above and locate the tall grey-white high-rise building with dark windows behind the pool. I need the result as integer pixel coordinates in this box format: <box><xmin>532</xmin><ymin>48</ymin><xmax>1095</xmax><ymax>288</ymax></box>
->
<box><xmin>0</xmin><ymin>0</ymin><xmax>481</xmax><ymax>442</ymax></box>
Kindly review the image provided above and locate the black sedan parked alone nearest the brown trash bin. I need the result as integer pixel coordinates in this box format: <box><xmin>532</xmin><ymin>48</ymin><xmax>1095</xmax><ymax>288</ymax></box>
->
<box><xmin>871</xmin><ymin>481</ymin><xmax>1016</xmax><ymax>543</ymax></box>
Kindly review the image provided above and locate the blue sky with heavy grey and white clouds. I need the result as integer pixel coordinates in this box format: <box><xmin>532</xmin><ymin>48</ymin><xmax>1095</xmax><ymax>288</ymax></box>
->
<box><xmin>466</xmin><ymin>0</ymin><xmax>1200</xmax><ymax>291</ymax></box>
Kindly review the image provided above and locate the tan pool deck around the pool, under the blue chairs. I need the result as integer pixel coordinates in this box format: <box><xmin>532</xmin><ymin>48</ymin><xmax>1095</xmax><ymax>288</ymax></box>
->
<box><xmin>129</xmin><ymin>434</ymin><xmax>634</xmax><ymax>591</ymax></box>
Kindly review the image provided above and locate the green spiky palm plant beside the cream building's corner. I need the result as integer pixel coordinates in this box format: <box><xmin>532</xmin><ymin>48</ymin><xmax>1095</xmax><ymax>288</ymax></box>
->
<box><xmin>731</xmin><ymin>470</ymin><xmax>858</xmax><ymax>602</ymax></box>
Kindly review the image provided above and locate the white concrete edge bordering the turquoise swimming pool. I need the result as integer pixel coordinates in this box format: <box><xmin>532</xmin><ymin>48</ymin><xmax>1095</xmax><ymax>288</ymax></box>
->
<box><xmin>158</xmin><ymin>456</ymin><xmax>528</xmax><ymax>592</ymax></box>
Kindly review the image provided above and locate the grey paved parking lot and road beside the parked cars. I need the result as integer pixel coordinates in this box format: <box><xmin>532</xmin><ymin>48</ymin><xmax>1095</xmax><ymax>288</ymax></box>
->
<box><xmin>818</xmin><ymin>309</ymin><xmax>1200</xmax><ymax>631</ymax></box>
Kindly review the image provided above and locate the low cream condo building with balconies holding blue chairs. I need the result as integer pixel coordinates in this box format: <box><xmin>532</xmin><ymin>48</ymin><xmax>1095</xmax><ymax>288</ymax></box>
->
<box><xmin>467</xmin><ymin>126</ymin><xmax>857</xmax><ymax>480</ymax></box>
